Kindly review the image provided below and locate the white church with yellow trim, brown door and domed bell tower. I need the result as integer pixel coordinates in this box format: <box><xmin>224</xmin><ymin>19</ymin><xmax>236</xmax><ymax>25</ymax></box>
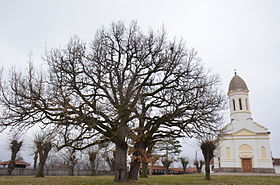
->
<box><xmin>214</xmin><ymin>73</ymin><xmax>275</xmax><ymax>173</ymax></box>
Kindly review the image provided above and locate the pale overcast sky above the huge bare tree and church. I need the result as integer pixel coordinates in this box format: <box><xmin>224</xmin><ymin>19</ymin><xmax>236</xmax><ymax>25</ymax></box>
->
<box><xmin>0</xmin><ymin>0</ymin><xmax>280</xmax><ymax>163</ymax></box>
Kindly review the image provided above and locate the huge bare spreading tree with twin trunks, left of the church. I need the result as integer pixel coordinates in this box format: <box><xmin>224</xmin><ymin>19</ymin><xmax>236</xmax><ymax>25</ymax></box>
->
<box><xmin>0</xmin><ymin>22</ymin><xmax>224</xmax><ymax>182</ymax></box>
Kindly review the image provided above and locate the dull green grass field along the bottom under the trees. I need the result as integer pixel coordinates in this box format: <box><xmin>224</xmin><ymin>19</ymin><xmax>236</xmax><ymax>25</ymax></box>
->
<box><xmin>0</xmin><ymin>175</ymin><xmax>280</xmax><ymax>185</ymax></box>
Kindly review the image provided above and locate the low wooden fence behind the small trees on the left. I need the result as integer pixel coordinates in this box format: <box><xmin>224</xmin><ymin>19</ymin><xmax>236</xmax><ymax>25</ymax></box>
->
<box><xmin>0</xmin><ymin>168</ymin><xmax>113</xmax><ymax>176</ymax></box>
